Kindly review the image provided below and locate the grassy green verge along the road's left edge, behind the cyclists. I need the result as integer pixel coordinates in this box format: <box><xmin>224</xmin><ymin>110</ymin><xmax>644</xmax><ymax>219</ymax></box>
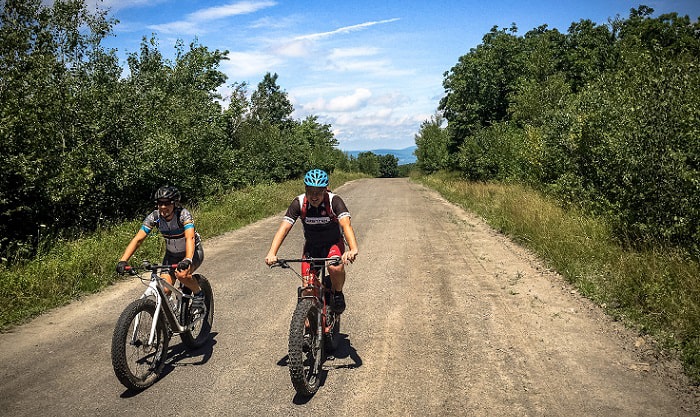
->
<box><xmin>0</xmin><ymin>172</ymin><xmax>364</xmax><ymax>331</ymax></box>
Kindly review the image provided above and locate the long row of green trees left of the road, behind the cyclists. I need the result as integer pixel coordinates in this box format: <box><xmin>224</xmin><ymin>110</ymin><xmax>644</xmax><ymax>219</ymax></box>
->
<box><xmin>0</xmin><ymin>0</ymin><xmax>396</xmax><ymax>267</ymax></box>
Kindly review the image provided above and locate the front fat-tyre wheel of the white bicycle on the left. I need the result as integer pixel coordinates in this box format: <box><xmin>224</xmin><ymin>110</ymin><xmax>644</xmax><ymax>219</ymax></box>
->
<box><xmin>112</xmin><ymin>298</ymin><xmax>169</xmax><ymax>391</ymax></box>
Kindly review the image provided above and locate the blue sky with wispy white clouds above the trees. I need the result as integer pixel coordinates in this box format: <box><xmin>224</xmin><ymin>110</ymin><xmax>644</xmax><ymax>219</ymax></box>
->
<box><xmin>93</xmin><ymin>0</ymin><xmax>700</xmax><ymax>150</ymax></box>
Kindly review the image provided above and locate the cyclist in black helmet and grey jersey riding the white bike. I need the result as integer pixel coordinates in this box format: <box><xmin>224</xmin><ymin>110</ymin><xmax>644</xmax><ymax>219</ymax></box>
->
<box><xmin>117</xmin><ymin>186</ymin><xmax>204</xmax><ymax>310</ymax></box>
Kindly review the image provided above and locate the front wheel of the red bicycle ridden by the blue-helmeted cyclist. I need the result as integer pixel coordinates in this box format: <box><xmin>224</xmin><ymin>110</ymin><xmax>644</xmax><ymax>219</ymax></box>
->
<box><xmin>289</xmin><ymin>299</ymin><xmax>325</xmax><ymax>397</ymax></box>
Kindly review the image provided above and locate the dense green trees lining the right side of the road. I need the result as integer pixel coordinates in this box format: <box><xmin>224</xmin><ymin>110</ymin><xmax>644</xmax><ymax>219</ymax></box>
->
<box><xmin>416</xmin><ymin>6</ymin><xmax>700</xmax><ymax>255</ymax></box>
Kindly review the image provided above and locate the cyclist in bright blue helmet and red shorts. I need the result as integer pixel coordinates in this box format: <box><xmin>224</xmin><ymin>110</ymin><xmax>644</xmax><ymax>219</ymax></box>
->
<box><xmin>265</xmin><ymin>169</ymin><xmax>358</xmax><ymax>313</ymax></box>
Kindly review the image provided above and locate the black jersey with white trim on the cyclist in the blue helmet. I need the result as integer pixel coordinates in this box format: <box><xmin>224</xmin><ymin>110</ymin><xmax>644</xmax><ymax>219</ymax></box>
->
<box><xmin>284</xmin><ymin>192</ymin><xmax>350</xmax><ymax>246</ymax></box>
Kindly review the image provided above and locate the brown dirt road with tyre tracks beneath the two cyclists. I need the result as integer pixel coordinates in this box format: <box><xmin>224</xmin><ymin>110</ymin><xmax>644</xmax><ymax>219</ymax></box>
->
<box><xmin>0</xmin><ymin>179</ymin><xmax>700</xmax><ymax>417</ymax></box>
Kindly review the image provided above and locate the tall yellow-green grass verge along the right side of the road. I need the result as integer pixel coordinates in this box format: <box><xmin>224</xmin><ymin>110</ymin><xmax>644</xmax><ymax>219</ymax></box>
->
<box><xmin>414</xmin><ymin>173</ymin><xmax>700</xmax><ymax>384</ymax></box>
